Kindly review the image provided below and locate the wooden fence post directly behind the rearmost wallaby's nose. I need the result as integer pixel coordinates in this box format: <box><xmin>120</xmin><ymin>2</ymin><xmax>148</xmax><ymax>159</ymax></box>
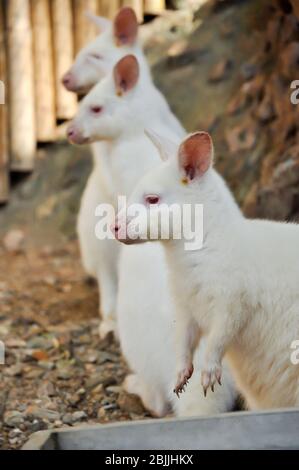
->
<box><xmin>51</xmin><ymin>0</ymin><xmax>77</xmax><ymax>120</ymax></box>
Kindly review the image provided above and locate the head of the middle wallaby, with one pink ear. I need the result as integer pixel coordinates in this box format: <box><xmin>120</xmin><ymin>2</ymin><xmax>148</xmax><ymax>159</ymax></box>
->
<box><xmin>67</xmin><ymin>55</ymin><xmax>142</xmax><ymax>145</ymax></box>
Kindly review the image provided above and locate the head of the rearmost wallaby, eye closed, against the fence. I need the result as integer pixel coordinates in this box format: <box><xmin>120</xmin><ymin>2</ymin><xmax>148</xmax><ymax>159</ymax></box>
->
<box><xmin>62</xmin><ymin>7</ymin><xmax>142</xmax><ymax>94</ymax></box>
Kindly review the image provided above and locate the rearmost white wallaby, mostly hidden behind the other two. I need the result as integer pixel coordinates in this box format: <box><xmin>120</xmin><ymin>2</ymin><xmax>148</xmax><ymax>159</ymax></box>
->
<box><xmin>63</xmin><ymin>7</ymin><xmax>183</xmax><ymax>337</ymax></box>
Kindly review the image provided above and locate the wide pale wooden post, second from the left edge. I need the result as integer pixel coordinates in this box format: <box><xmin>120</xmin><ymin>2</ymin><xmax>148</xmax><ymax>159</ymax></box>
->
<box><xmin>6</xmin><ymin>0</ymin><xmax>36</xmax><ymax>171</ymax></box>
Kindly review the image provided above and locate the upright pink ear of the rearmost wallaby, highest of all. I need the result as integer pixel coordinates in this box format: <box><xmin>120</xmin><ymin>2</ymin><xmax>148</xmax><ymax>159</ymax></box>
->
<box><xmin>114</xmin><ymin>7</ymin><xmax>138</xmax><ymax>46</ymax></box>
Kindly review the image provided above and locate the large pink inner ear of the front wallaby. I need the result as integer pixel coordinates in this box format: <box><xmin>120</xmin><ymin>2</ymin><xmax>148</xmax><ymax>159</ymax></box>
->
<box><xmin>179</xmin><ymin>132</ymin><xmax>214</xmax><ymax>181</ymax></box>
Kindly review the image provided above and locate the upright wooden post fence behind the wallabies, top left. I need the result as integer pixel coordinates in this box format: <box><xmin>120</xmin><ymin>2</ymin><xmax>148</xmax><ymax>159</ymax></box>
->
<box><xmin>0</xmin><ymin>0</ymin><xmax>165</xmax><ymax>204</ymax></box>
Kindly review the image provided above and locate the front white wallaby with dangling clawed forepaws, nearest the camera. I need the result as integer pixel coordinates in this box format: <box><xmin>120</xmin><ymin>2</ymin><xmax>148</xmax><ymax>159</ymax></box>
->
<box><xmin>116</xmin><ymin>132</ymin><xmax>299</xmax><ymax>409</ymax></box>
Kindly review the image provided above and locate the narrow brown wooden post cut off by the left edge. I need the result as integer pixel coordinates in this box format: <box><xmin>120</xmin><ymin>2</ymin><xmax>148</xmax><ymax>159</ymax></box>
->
<box><xmin>0</xmin><ymin>1</ymin><xmax>9</xmax><ymax>200</ymax></box>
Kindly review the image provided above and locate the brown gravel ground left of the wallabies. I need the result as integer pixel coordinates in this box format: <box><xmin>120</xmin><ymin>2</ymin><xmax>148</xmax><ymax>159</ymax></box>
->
<box><xmin>0</xmin><ymin>241</ymin><xmax>149</xmax><ymax>449</ymax></box>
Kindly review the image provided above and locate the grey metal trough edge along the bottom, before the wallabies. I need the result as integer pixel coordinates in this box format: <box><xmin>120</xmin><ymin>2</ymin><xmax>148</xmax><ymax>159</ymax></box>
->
<box><xmin>24</xmin><ymin>409</ymin><xmax>299</xmax><ymax>451</ymax></box>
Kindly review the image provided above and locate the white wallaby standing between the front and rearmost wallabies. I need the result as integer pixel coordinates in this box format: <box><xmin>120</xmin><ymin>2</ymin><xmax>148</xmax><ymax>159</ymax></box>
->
<box><xmin>68</xmin><ymin>56</ymin><xmax>239</xmax><ymax>416</ymax></box>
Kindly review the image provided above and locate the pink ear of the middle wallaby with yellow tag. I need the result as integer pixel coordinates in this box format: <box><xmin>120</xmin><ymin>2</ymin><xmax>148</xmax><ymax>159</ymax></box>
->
<box><xmin>114</xmin><ymin>55</ymin><xmax>140</xmax><ymax>96</ymax></box>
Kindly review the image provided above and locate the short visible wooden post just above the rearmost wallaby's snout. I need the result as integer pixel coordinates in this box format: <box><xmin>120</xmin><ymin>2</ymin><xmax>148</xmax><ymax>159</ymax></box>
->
<box><xmin>73</xmin><ymin>0</ymin><xmax>98</xmax><ymax>54</ymax></box>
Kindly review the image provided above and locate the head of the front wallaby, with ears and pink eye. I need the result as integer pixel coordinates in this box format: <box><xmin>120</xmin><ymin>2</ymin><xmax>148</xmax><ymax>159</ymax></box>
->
<box><xmin>113</xmin><ymin>132</ymin><xmax>215</xmax><ymax>244</ymax></box>
